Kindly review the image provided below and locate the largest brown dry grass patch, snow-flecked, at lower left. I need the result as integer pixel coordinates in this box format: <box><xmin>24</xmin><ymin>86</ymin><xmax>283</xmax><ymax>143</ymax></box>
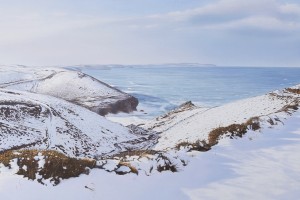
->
<box><xmin>0</xmin><ymin>150</ymin><xmax>96</xmax><ymax>185</ymax></box>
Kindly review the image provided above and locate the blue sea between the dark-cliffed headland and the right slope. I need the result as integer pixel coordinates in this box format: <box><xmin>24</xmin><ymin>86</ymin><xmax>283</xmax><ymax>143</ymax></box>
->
<box><xmin>79</xmin><ymin>65</ymin><xmax>300</xmax><ymax>118</ymax></box>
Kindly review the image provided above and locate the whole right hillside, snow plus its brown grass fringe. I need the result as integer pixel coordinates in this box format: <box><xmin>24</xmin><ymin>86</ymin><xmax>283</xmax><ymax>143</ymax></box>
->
<box><xmin>110</xmin><ymin>85</ymin><xmax>300</xmax><ymax>151</ymax></box>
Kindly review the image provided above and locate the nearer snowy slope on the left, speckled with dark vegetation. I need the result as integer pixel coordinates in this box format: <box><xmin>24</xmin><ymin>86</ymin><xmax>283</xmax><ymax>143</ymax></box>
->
<box><xmin>0</xmin><ymin>89</ymin><xmax>156</xmax><ymax>157</ymax></box>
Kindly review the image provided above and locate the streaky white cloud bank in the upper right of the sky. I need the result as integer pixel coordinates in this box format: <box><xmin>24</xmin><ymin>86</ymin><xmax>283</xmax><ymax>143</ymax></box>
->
<box><xmin>141</xmin><ymin>0</ymin><xmax>300</xmax><ymax>32</ymax></box>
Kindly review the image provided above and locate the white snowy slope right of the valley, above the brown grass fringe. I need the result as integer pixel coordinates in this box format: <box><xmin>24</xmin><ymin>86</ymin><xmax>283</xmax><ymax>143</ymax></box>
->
<box><xmin>137</xmin><ymin>85</ymin><xmax>300</xmax><ymax>150</ymax></box>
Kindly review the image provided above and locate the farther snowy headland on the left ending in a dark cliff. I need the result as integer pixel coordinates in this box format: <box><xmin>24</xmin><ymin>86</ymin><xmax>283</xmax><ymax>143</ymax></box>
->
<box><xmin>0</xmin><ymin>66</ymin><xmax>138</xmax><ymax>115</ymax></box>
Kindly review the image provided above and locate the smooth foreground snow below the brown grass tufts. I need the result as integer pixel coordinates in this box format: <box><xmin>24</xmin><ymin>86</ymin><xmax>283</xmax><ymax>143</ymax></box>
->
<box><xmin>0</xmin><ymin>112</ymin><xmax>300</xmax><ymax>200</ymax></box>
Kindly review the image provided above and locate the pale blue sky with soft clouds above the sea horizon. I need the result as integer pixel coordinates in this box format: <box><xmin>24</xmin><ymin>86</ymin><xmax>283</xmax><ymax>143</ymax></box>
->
<box><xmin>0</xmin><ymin>0</ymin><xmax>300</xmax><ymax>67</ymax></box>
